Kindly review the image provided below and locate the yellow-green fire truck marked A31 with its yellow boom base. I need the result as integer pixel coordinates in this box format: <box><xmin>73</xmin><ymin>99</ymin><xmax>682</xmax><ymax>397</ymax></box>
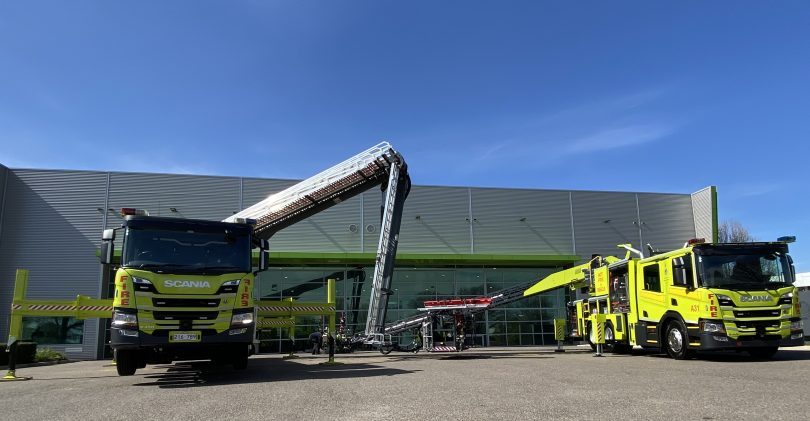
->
<box><xmin>524</xmin><ymin>240</ymin><xmax>804</xmax><ymax>359</ymax></box>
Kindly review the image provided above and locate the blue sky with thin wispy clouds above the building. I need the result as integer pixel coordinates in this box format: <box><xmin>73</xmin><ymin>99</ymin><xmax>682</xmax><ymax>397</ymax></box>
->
<box><xmin>0</xmin><ymin>0</ymin><xmax>810</xmax><ymax>271</ymax></box>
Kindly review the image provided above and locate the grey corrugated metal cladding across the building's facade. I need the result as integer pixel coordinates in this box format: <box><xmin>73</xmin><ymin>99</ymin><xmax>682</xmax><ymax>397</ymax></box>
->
<box><xmin>0</xmin><ymin>166</ymin><xmax>716</xmax><ymax>359</ymax></box>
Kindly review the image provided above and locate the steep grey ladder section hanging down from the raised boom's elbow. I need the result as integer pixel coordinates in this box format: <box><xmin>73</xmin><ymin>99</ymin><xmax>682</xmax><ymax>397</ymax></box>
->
<box><xmin>365</xmin><ymin>161</ymin><xmax>411</xmax><ymax>344</ymax></box>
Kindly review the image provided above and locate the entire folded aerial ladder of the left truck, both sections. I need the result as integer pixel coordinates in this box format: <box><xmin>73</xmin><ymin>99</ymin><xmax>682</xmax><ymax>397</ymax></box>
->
<box><xmin>224</xmin><ymin>142</ymin><xmax>411</xmax><ymax>345</ymax></box>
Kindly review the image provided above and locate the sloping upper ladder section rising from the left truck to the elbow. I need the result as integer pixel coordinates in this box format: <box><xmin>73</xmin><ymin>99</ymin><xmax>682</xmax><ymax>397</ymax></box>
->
<box><xmin>224</xmin><ymin>142</ymin><xmax>405</xmax><ymax>239</ymax></box>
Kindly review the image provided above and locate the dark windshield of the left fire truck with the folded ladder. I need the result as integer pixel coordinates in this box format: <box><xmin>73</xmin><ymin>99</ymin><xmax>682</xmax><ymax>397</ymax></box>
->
<box><xmin>122</xmin><ymin>227</ymin><xmax>251</xmax><ymax>274</ymax></box>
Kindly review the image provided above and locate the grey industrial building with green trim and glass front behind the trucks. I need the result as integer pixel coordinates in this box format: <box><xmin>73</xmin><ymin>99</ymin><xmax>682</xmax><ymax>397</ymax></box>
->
<box><xmin>0</xmin><ymin>165</ymin><xmax>717</xmax><ymax>359</ymax></box>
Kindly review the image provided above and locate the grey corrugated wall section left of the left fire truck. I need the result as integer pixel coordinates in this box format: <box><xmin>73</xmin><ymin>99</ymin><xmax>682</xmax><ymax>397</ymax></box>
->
<box><xmin>0</xmin><ymin>170</ymin><xmax>107</xmax><ymax>358</ymax></box>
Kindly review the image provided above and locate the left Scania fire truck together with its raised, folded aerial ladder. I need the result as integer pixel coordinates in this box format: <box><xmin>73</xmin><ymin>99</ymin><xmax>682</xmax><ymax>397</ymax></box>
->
<box><xmin>101</xmin><ymin>142</ymin><xmax>410</xmax><ymax>375</ymax></box>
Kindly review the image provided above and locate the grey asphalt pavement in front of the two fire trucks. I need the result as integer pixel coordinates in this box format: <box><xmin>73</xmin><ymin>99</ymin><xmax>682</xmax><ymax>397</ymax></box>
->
<box><xmin>0</xmin><ymin>346</ymin><xmax>810</xmax><ymax>420</ymax></box>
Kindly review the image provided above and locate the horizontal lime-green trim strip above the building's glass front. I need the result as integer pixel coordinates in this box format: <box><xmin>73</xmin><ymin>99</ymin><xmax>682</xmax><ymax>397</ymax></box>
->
<box><xmin>254</xmin><ymin>252</ymin><xmax>582</xmax><ymax>267</ymax></box>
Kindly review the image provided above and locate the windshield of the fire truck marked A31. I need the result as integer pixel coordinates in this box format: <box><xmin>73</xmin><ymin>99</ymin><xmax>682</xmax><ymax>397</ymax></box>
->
<box><xmin>697</xmin><ymin>252</ymin><xmax>793</xmax><ymax>289</ymax></box>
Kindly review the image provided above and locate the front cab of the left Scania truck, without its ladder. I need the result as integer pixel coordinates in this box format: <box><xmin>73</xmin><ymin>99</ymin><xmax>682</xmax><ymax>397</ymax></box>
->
<box><xmin>101</xmin><ymin>209</ymin><xmax>267</xmax><ymax>375</ymax></box>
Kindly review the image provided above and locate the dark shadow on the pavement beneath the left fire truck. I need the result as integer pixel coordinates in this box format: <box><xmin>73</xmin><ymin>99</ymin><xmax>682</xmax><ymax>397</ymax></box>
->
<box><xmin>133</xmin><ymin>359</ymin><xmax>420</xmax><ymax>388</ymax></box>
